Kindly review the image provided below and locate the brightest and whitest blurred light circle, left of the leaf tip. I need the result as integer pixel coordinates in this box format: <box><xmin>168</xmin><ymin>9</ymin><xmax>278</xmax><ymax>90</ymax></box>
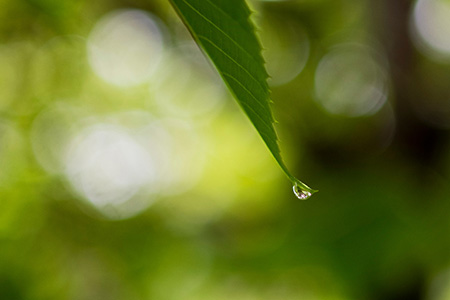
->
<box><xmin>65</xmin><ymin>124</ymin><xmax>155</xmax><ymax>217</ymax></box>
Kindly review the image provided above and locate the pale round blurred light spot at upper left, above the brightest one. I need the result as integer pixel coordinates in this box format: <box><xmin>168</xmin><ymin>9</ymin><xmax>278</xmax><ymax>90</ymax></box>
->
<box><xmin>87</xmin><ymin>10</ymin><xmax>164</xmax><ymax>87</ymax></box>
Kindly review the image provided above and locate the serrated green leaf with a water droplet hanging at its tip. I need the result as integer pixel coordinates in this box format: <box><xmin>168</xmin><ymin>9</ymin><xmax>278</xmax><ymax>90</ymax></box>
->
<box><xmin>170</xmin><ymin>0</ymin><xmax>316</xmax><ymax>198</ymax></box>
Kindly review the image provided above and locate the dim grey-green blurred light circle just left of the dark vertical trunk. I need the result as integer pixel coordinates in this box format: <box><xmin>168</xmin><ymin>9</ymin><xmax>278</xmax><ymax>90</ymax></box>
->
<box><xmin>315</xmin><ymin>44</ymin><xmax>388</xmax><ymax>117</ymax></box>
